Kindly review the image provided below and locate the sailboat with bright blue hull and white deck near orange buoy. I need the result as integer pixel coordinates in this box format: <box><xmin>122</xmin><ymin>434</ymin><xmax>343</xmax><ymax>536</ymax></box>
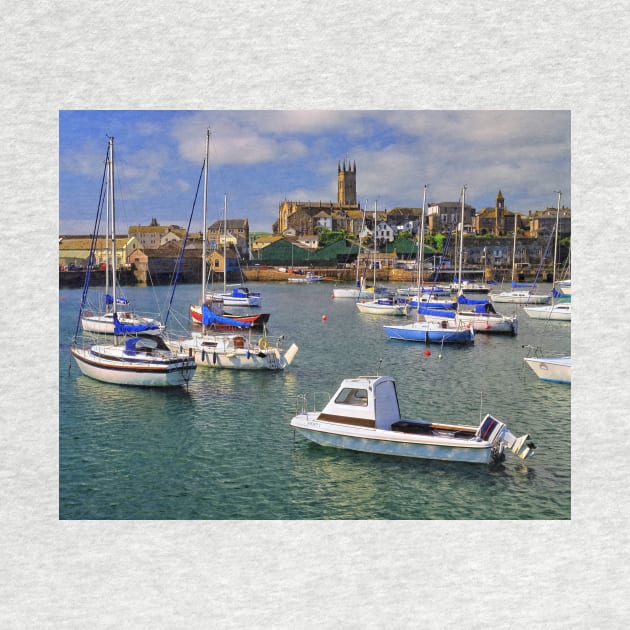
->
<box><xmin>383</xmin><ymin>185</ymin><xmax>475</xmax><ymax>344</ymax></box>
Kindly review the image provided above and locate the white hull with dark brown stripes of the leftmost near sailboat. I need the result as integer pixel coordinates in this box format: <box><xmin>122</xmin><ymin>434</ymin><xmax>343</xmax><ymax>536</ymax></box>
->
<box><xmin>70</xmin><ymin>346</ymin><xmax>197</xmax><ymax>387</ymax></box>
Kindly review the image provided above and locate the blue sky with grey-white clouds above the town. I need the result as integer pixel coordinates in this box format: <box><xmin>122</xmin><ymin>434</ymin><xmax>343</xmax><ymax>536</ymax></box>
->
<box><xmin>59</xmin><ymin>110</ymin><xmax>571</xmax><ymax>234</ymax></box>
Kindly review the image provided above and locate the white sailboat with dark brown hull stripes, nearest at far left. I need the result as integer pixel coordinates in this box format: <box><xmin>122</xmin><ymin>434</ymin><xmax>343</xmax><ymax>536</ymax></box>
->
<box><xmin>70</xmin><ymin>137</ymin><xmax>197</xmax><ymax>387</ymax></box>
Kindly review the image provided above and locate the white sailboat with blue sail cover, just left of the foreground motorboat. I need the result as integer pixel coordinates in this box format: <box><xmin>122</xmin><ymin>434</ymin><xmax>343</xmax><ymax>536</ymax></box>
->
<box><xmin>169</xmin><ymin>130</ymin><xmax>298</xmax><ymax>370</ymax></box>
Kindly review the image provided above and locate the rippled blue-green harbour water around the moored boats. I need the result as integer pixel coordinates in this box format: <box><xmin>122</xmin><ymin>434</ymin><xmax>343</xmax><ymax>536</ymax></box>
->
<box><xmin>59</xmin><ymin>283</ymin><xmax>571</xmax><ymax>520</ymax></box>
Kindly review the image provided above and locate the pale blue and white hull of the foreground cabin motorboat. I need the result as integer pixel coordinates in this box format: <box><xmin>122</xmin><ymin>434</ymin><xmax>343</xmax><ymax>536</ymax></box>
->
<box><xmin>291</xmin><ymin>414</ymin><xmax>492</xmax><ymax>464</ymax></box>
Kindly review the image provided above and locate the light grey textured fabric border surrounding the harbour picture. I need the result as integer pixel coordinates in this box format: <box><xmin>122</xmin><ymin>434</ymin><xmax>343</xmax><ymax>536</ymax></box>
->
<box><xmin>0</xmin><ymin>0</ymin><xmax>630</xmax><ymax>628</ymax></box>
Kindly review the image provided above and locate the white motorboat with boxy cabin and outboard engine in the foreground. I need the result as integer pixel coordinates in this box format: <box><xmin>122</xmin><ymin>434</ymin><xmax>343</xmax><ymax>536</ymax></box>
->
<box><xmin>290</xmin><ymin>376</ymin><xmax>536</xmax><ymax>464</ymax></box>
